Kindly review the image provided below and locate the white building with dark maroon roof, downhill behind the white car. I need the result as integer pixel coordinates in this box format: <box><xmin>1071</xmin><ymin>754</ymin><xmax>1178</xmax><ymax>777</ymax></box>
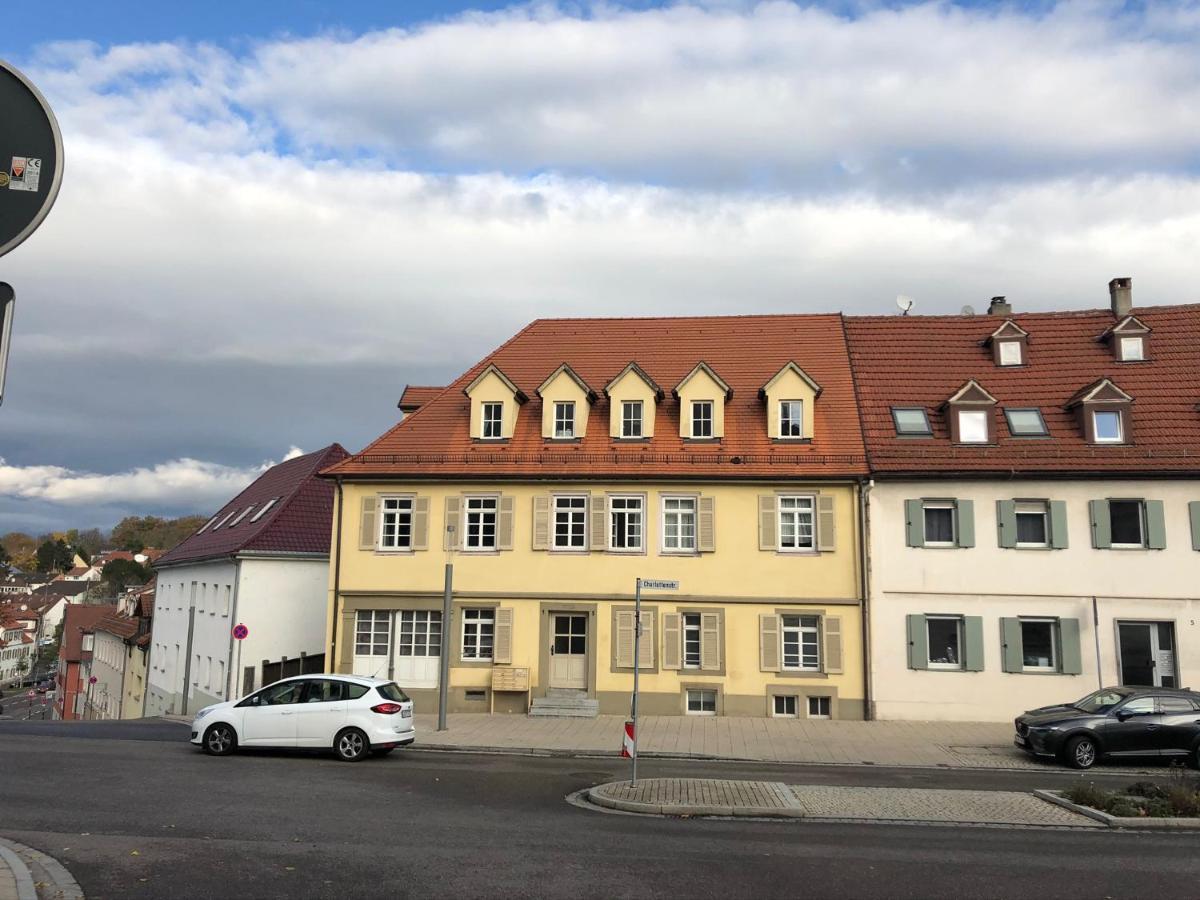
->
<box><xmin>145</xmin><ymin>444</ymin><xmax>347</xmax><ymax>715</ymax></box>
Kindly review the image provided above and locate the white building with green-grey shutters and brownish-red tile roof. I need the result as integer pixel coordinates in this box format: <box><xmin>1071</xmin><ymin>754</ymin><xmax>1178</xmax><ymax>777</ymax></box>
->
<box><xmin>847</xmin><ymin>280</ymin><xmax>1200</xmax><ymax>721</ymax></box>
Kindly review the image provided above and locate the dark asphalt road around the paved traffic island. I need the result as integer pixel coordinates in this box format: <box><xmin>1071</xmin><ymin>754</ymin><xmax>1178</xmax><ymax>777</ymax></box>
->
<box><xmin>0</xmin><ymin>721</ymin><xmax>1200</xmax><ymax>900</ymax></box>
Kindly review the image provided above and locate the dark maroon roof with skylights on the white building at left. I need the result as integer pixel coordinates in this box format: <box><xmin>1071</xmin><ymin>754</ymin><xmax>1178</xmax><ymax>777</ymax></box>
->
<box><xmin>155</xmin><ymin>444</ymin><xmax>348</xmax><ymax>566</ymax></box>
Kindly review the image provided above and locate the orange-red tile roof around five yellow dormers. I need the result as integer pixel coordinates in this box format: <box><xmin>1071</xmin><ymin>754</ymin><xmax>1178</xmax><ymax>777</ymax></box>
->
<box><xmin>326</xmin><ymin>314</ymin><xmax>866</xmax><ymax>487</ymax></box>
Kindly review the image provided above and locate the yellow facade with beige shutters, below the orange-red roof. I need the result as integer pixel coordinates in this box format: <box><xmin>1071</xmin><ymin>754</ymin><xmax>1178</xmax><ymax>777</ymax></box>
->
<box><xmin>329</xmin><ymin>482</ymin><xmax>864</xmax><ymax>718</ymax></box>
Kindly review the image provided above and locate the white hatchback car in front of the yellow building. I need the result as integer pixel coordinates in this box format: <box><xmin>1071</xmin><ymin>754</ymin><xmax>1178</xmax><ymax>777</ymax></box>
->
<box><xmin>192</xmin><ymin>674</ymin><xmax>416</xmax><ymax>762</ymax></box>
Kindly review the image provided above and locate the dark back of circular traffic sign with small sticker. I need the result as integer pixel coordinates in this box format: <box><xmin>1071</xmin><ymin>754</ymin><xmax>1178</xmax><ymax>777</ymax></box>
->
<box><xmin>0</xmin><ymin>60</ymin><xmax>62</xmax><ymax>256</ymax></box>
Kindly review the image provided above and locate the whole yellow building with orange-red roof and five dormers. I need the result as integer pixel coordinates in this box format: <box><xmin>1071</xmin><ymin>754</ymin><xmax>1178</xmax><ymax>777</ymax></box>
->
<box><xmin>326</xmin><ymin>316</ymin><xmax>866</xmax><ymax>719</ymax></box>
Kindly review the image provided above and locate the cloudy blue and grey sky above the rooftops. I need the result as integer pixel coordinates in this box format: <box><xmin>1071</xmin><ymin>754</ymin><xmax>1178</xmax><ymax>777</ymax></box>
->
<box><xmin>0</xmin><ymin>0</ymin><xmax>1200</xmax><ymax>533</ymax></box>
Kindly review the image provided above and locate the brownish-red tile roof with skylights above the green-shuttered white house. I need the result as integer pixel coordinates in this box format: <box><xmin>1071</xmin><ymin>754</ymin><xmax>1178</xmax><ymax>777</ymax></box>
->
<box><xmin>846</xmin><ymin>305</ymin><xmax>1200</xmax><ymax>475</ymax></box>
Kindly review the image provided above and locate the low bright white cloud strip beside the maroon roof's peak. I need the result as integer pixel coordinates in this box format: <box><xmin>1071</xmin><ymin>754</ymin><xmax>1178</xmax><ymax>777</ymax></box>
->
<box><xmin>0</xmin><ymin>446</ymin><xmax>304</xmax><ymax>509</ymax></box>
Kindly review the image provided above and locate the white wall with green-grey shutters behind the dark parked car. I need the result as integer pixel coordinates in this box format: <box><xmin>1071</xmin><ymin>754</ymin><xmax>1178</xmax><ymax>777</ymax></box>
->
<box><xmin>869</xmin><ymin>480</ymin><xmax>1200</xmax><ymax>721</ymax></box>
